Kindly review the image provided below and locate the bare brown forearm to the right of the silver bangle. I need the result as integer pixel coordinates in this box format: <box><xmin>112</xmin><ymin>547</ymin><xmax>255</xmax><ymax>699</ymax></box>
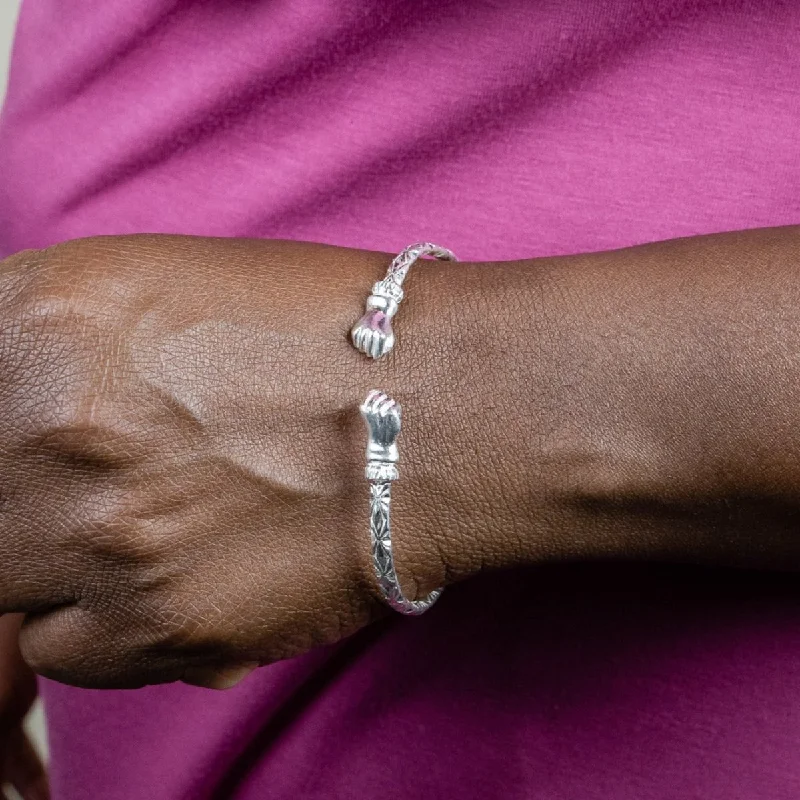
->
<box><xmin>395</xmin><ymin>228</ymin><xmax>800</xmax><ymax>592</ymax></box>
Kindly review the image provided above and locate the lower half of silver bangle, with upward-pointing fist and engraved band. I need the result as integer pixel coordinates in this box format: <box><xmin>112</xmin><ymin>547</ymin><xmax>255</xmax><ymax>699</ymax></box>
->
<box><xmin>361</xmin><ymin>389</ymin><xmax>442</xmax><ymax>616</ymax></box>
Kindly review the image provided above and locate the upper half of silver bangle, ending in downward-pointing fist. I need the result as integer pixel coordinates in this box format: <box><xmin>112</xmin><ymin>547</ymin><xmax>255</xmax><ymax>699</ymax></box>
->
<box><xmin>350</xmin><ymin>242</ymin><xmax>458</xmax><ymax>358</ymax></box>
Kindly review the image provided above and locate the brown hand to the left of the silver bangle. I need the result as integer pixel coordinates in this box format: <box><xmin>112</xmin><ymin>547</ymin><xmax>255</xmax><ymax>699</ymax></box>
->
<box><xmin>0</xmin><ymin>237</ymin><xmax>462</xmax><ymax>687</ymax></box>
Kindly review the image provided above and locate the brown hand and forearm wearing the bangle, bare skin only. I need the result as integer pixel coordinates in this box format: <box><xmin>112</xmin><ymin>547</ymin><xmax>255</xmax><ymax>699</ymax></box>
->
<box><xmin>0</xmin><ymin>228</ymin><xmax>800</xmax><ymax>704</ymax></box>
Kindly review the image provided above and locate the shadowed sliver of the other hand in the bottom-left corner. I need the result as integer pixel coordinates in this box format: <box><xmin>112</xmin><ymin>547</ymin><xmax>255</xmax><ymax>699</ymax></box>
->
<box><xmin>0</xmin><ymin>614</ymin><xmax>49</xmax><ymax>800</ymax></box>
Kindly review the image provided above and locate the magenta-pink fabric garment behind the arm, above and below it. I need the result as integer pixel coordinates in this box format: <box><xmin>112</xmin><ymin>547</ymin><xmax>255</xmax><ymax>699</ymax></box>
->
<box><xmin>0</xmin><ymin>0</ymin><xmax>800</xmax><ymax>800</ymax></box>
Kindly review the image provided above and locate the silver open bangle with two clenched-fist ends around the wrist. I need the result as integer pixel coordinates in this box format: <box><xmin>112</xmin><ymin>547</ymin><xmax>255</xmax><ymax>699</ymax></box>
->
<box><xmin>351</xmin><ymin>242</ymin><xmax>457</xmax><ymax>616</ymax></box>
